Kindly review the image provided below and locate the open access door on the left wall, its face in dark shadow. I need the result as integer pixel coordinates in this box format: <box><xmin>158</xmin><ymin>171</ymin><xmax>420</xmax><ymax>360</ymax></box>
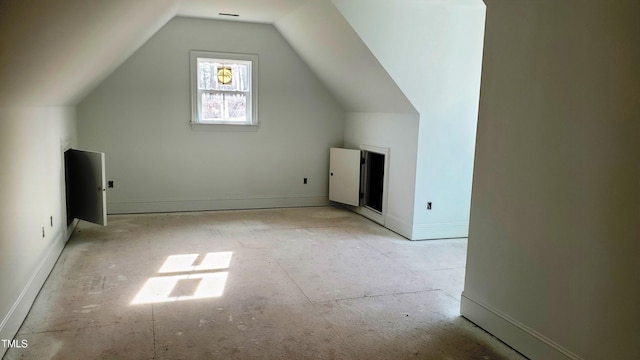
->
<box><xmin>64</xmin><ymin>149</ymin><xmax>107</xmax><ymax>226</ymax></box>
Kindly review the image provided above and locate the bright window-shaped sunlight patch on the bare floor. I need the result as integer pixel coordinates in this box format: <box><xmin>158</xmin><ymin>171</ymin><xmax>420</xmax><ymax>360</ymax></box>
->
<box><xmin>131</xmin><ymin>251</ymin><xmax>233</xmax><ymax>305</ymax></box>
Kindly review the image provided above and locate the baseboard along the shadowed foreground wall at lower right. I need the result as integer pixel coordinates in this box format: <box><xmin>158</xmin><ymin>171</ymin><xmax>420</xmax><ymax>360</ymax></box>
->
<box><xmin>460</xmin><ymin>292</ymin><xmax>582</xmax><ymax>360</ymax></box>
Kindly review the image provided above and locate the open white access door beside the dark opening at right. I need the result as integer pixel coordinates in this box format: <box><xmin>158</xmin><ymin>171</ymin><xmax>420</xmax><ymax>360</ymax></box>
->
<box><xmin>329</xmin><ymin>148</ymin><xmax>360</xmax><ymax>206</ymax></box>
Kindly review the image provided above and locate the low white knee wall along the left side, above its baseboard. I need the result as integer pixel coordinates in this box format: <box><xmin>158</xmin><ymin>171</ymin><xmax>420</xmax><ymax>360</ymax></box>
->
<box><xmin>0</xmin><ymin>107</ymin><xmax>76</xmax><ymax>357</ymax></box>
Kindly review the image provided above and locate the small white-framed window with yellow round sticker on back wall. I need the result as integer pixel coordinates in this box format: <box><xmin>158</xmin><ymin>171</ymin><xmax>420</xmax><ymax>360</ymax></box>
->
<box><xmin>190</xmin><ymin>51</ymin><xmax>258</xmax><ymax>128</ymax></box>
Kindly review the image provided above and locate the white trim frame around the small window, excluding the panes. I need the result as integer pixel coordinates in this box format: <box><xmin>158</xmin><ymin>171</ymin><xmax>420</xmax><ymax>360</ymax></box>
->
<box><xmin>189</xmin><ymin>50</ymin><xmax>260</xmax><ymax>131</ymax></box>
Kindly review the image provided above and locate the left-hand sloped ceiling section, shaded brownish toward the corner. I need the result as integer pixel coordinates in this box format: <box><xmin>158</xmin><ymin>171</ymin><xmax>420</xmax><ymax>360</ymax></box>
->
<box><xmin>0</xmin><ymin>0</ymin><xmax>179</xmax><ymax>107</ymax></box>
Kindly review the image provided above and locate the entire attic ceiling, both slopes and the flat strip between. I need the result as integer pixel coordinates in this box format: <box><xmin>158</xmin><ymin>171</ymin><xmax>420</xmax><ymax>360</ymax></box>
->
<box><xmin>0</xmin><ymin>0</ymin><xmax>415</xmax><ymax>113</ymax></box>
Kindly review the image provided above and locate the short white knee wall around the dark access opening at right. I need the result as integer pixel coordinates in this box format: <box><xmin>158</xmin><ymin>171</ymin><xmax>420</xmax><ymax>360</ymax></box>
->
<box><xmin>344</xmin><ymin>112</ymin><xmax>419</xmax><ymax>238</ymax></box>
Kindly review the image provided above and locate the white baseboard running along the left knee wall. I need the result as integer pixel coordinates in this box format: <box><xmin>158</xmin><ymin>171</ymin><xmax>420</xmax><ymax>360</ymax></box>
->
<box><xmin>0</xmin><ymin>225</ymin><xmax>73</xmax><ymax>358</ymax></box>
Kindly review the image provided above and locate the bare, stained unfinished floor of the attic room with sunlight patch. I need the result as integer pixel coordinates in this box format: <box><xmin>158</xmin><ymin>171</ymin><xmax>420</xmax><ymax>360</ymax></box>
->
<box><xmin>5</xmin><ymin>207</ymin><xmax>524</xmax><ymax>360</ymax></box>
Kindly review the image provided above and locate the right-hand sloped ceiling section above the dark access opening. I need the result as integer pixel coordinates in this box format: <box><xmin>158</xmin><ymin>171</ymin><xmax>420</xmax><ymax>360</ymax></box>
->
<box><xmin>274</xmin><ymin>0</ymin><xmax>416</xmax><ymax>114</ymax></box>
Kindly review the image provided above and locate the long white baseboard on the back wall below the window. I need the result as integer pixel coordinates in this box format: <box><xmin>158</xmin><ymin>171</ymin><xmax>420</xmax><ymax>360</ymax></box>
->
<box><xmin>107</xmin><ymin>196</ymin><xmax>330</xmax><ymax>214</ymax></box>
